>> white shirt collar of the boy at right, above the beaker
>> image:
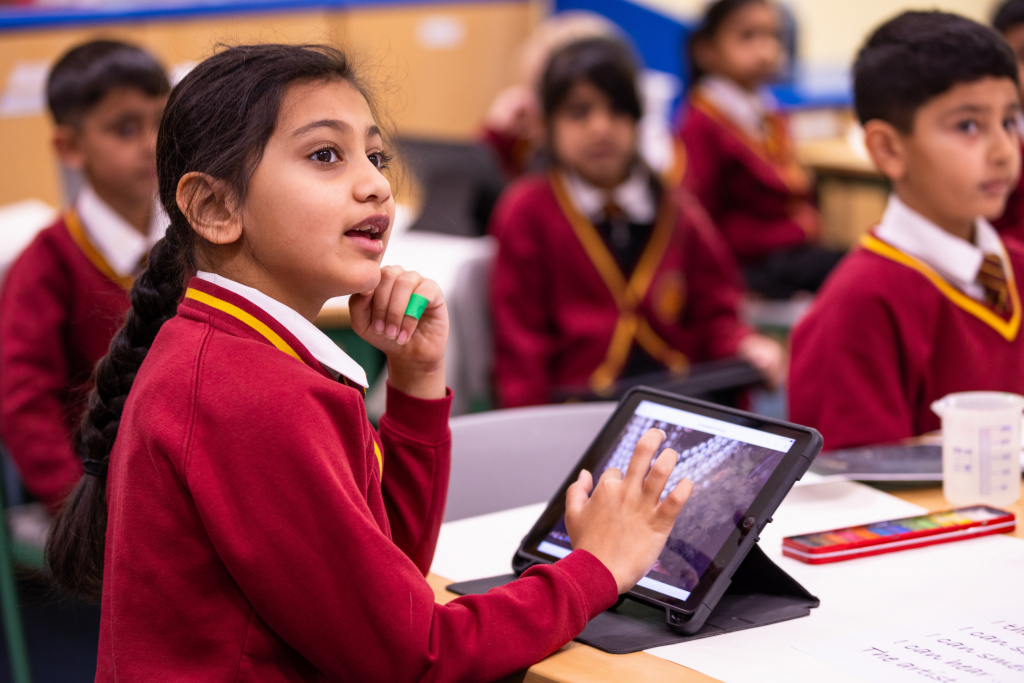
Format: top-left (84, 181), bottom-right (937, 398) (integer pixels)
top-left (874, 194), bottom-right (1009, 301)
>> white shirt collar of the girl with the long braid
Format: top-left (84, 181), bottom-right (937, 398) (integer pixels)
top-left (196, 270), bottom-right (370, 387)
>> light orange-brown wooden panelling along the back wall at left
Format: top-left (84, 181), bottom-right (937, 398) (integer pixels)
top-left (0, 0), bottom-right (546, 206)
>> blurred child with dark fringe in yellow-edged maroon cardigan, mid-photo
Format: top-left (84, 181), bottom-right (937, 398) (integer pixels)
top-left (490, 38), bottom-right (784, 407)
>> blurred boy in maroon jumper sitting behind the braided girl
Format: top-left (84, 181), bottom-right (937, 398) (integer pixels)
top-left (0, 41), bottom-right (170, 510)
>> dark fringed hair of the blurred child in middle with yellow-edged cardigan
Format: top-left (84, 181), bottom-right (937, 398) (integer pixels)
top-left (541, 37), bottom-right (643, 121)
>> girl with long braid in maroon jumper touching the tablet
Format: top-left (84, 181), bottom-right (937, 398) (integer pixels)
top-left (41, 45), bottom-right (689, 681)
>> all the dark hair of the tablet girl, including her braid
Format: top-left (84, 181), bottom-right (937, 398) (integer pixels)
top-left (46, 45), bottom-right (374, 599)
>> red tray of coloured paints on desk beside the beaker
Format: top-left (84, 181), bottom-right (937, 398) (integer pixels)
top-left (782, 505), bottom-right (1017, 564)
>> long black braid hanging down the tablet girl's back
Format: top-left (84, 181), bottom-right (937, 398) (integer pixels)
top-left (46, 225), bottom-right (191, 599)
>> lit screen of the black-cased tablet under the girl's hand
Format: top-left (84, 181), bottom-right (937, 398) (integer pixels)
top-left (538, 400), bottom-right (795, 600)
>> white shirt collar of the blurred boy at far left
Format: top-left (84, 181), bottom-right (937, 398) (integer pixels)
top-left (75, 183), bottom-right (170, 278)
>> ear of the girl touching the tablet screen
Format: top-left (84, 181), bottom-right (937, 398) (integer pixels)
top-left (176, 172), bottom-right (242, 245)
